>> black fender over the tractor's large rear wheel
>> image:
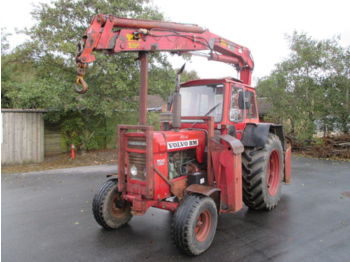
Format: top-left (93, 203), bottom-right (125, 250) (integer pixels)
top-left (242, 123), bottom-right (286, 151)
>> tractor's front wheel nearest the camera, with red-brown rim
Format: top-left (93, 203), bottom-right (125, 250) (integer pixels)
top-left (171, 195), bottom-right (218, 256)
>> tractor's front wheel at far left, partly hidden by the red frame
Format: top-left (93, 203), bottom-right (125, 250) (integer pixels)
top-left (92, 179), bottom-right (132, 230)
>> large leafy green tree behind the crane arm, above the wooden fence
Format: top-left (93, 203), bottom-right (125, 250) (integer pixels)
top-left (1, 0), bottom-right (197, 149)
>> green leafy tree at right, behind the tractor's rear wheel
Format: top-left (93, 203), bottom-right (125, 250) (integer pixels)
top-left (257, 32), bottom-right (349, 140)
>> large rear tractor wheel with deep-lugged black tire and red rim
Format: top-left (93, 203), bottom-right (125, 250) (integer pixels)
top-left (242, 133), bottom-right (284, 210)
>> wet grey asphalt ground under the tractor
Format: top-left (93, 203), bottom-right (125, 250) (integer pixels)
top-left (1, 158), bottom-right (350, 262)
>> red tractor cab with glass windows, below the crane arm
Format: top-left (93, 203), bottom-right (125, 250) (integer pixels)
top-left (180, 78), bottom-right (259, 139)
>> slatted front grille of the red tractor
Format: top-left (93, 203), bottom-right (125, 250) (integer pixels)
top-left (128, 137), bottom-right (146, 180)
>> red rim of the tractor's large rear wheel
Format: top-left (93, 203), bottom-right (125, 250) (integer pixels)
top-left (267, 150), bottom-right (280, 196)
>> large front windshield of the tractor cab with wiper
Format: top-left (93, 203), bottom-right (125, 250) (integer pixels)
top-left (180, 84), bottom-right (224, 122)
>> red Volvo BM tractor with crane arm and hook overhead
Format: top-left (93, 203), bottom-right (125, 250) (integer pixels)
top-left (76, 14), bottom-right (291, 255)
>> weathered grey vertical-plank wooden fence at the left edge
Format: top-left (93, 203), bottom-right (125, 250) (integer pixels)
top-left (1, 109), bottom-right (45, 165)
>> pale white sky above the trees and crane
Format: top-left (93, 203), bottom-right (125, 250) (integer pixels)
top-left (1, 0), bottom-right (350, 82)
